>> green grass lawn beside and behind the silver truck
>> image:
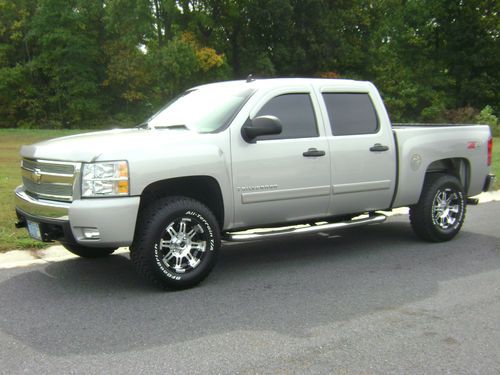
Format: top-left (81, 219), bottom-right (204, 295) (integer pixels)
top-left (0, 129), bottom-right (500, 251)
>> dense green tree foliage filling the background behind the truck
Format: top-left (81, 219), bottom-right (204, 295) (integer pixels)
top-left (0, 0), bottom-right (500, 128)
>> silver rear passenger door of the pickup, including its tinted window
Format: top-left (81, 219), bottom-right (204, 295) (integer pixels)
top-left (321, 89), bottom-right (396, 215)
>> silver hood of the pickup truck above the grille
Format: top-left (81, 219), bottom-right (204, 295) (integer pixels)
top-left (21, 128), bottom-right (203, 162)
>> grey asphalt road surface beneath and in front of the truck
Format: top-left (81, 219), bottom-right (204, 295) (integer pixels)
top-left (0, 202), bottom-right (500, 375)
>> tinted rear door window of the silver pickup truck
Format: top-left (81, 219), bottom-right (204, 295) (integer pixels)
top-left (323, 93), bottom-right (378, 135)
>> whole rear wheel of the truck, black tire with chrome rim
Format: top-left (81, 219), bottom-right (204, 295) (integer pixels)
top-left (410, 173), bottom-right (466, 242)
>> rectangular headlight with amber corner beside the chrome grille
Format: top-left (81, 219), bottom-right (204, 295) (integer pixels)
top-left (82, 161), bottom-right (129, 197)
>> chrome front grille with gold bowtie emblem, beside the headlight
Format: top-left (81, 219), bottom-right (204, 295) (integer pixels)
top-left (21, 159), bottom-right (80, 202)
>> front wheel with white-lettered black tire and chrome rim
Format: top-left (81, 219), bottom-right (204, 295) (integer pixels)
top-left (130, 197), bottom-right (220, 289)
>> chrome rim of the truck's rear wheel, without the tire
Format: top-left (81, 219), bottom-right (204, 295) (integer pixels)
top-left (432, 188), bottom-right (462, 230)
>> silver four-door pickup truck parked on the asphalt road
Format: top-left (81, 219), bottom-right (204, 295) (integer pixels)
top-left (15, 79), bottom-right (494, 288)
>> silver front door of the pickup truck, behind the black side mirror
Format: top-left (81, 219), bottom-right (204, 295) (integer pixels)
top-left (231, 85), bottom-right (330, 227)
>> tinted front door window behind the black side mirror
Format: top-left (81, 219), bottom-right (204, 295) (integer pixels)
top-left (257, 94), bottom-right (318, 140)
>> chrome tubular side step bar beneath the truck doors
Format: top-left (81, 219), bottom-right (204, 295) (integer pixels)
top-left (222, 213), bottom-right (387, 242)
